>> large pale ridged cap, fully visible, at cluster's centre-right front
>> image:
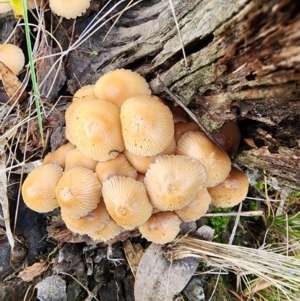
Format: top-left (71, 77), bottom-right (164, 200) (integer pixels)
top-left (144, 155), bottom-right (206, 211)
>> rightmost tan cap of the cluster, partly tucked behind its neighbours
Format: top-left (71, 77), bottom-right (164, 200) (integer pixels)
top-left (208, 166), bottom-right (249, 208)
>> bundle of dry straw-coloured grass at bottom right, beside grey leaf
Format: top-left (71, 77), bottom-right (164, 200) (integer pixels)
top-left (167, 236), bottom-right (300, 300)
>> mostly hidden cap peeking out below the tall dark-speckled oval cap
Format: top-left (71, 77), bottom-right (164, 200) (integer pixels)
top-left (123, 138), bottom-right (176, 173)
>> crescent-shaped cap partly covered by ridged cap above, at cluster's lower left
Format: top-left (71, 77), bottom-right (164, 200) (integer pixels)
top-left (61, 200), bottom-right (109, 235)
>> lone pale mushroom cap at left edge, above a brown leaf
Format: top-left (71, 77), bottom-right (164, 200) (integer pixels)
top-left (0, 44), bottom-right (25, 75)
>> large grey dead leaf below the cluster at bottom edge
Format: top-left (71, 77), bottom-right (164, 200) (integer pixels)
top-left (134, 243), bottom-right (199, 301)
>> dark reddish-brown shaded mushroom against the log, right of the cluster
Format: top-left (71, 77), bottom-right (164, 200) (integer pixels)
top-left (212, 121), bottom-right (241, 157)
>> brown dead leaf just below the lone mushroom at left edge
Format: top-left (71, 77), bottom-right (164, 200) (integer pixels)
top-left (0, 62), bottom-right (27, 105)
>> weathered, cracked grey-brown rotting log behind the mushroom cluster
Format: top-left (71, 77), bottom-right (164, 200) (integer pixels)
top-left (67, 0), bottom-right (300, 189)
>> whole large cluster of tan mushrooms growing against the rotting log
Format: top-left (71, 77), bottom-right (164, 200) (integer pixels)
top-left (22, 69), bottom-right (248, 244)
